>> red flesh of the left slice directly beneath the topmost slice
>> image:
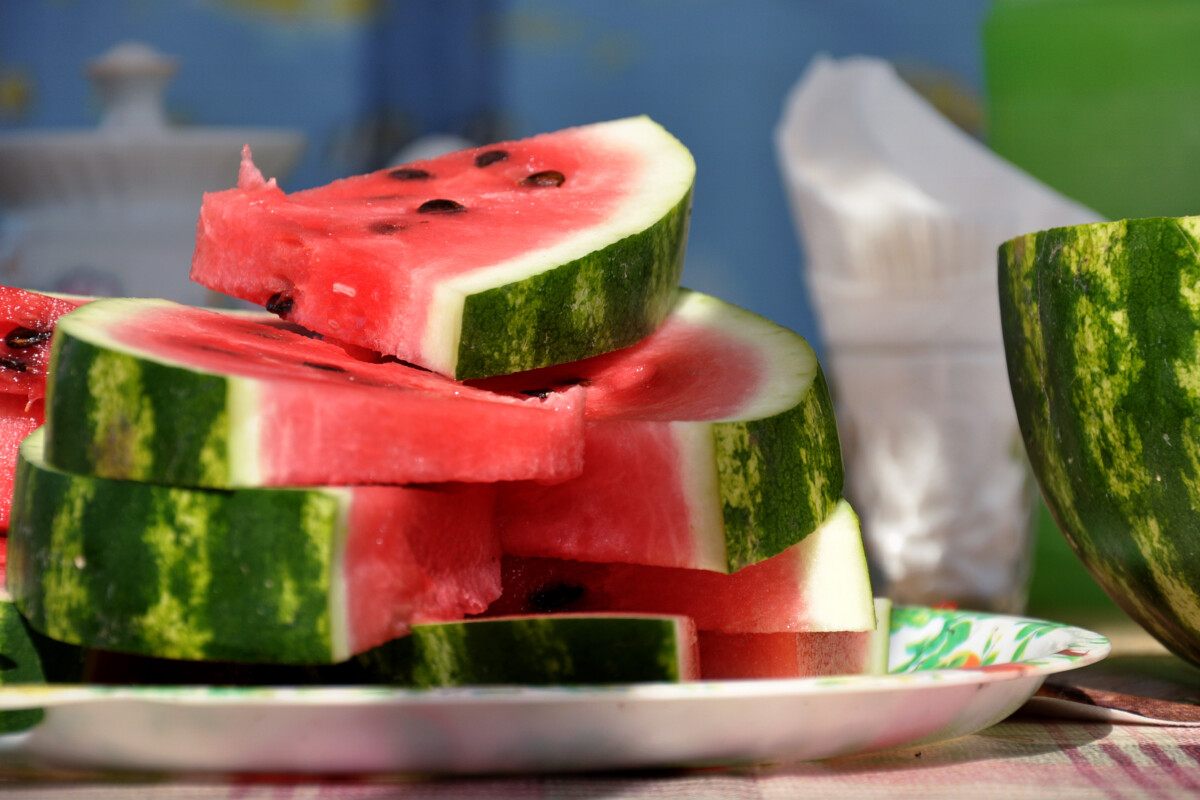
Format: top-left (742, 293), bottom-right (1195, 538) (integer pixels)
top-left (106, 301), bottom-right (583, 486)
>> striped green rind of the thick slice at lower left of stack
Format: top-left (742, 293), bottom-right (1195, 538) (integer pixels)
top-left (7, 428), bottom-right (350, 663)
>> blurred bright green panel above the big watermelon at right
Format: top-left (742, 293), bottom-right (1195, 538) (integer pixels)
top-left (983, 0), bottom-right (1200, 219)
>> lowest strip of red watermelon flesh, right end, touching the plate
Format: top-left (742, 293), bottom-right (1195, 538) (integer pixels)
top-left (700, 631), bottom-right (874, 680)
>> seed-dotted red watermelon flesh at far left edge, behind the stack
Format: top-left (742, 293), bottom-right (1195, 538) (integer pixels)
top-left (0, 285), bottom-right (88, 402)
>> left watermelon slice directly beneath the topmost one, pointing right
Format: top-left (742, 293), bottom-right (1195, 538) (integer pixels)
top-left (46, 299), bottom-right (583, 488)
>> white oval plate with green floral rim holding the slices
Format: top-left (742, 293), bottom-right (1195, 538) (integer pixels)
top-left (0, 607), bottom-right (1110, 774)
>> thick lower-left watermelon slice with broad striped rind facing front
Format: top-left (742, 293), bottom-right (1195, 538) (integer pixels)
top-left (7, 427), bottom-right (500, 663)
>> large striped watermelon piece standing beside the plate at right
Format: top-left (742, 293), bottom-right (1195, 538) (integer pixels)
top-left (1000, 217), bottom-right (1200, 663)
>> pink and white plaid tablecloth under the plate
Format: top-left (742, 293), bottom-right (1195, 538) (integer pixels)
top-left (0, 714), bottom-right (1200, 800)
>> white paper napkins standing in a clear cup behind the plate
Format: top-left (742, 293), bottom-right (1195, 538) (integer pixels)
top-left (775, 56), bottom-right (1099, 613)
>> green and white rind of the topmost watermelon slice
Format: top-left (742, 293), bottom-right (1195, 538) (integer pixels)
top-left (419, 115), bottom-right (696, 380)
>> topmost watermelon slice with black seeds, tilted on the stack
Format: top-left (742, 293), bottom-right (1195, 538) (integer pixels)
top-left (191, 116), bottom-right (695, 378)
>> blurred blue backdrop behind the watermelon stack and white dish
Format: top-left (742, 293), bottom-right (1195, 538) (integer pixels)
top-left (0, 0), bottom-right (988, 357)
